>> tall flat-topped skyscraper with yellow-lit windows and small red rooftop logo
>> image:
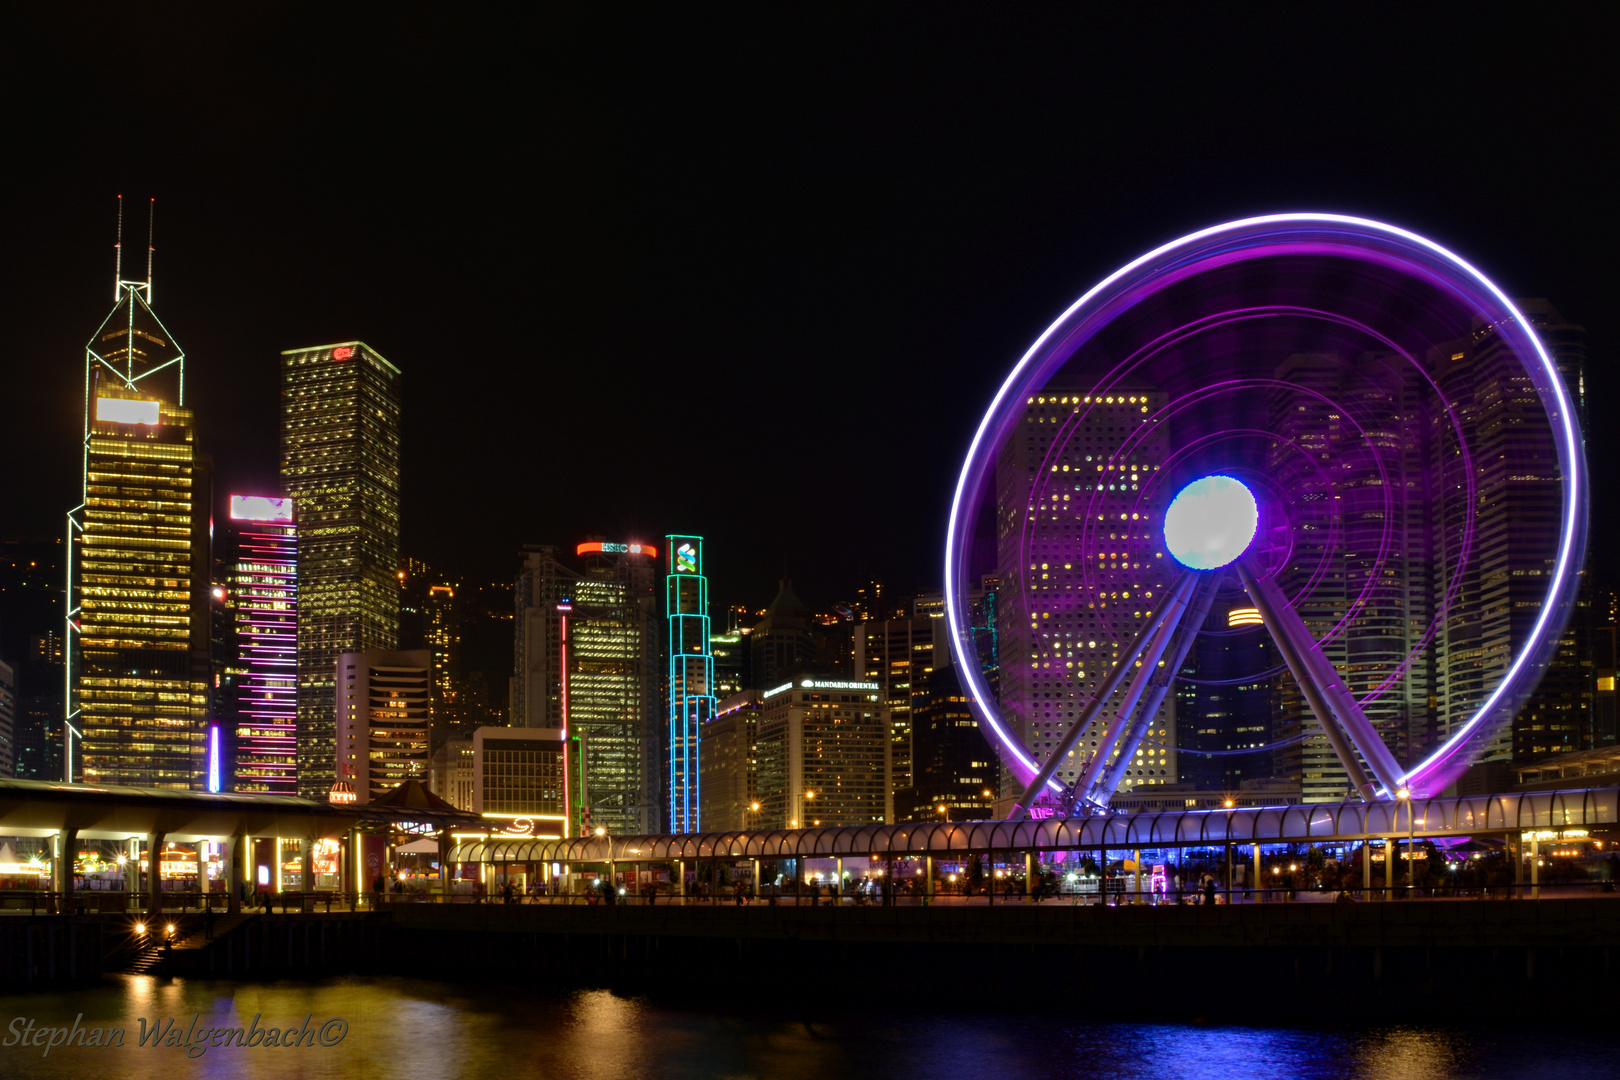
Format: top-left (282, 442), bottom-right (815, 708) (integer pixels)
top-left (282, 342), bottom-right (400, 798)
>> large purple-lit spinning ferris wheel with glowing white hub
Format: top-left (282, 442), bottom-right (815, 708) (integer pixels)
top-left (944, 214), bottom-right (1586, 819)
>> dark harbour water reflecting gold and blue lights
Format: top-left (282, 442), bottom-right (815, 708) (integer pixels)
top-left (0, 973), bottom-right (1620, 1080)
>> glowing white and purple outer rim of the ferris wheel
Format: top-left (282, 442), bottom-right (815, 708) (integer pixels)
top-left (944, 212), bottom-right (1589, 803)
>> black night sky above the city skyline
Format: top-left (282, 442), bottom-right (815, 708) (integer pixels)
top-left (0, 5), bottom-right (1620, 606)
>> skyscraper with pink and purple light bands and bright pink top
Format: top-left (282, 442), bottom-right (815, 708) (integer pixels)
top-left (214, 495), bottom-right (298, 795)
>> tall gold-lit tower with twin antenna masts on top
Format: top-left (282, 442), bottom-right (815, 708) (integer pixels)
top-left (63, 196), bottom-right (212, 789)
